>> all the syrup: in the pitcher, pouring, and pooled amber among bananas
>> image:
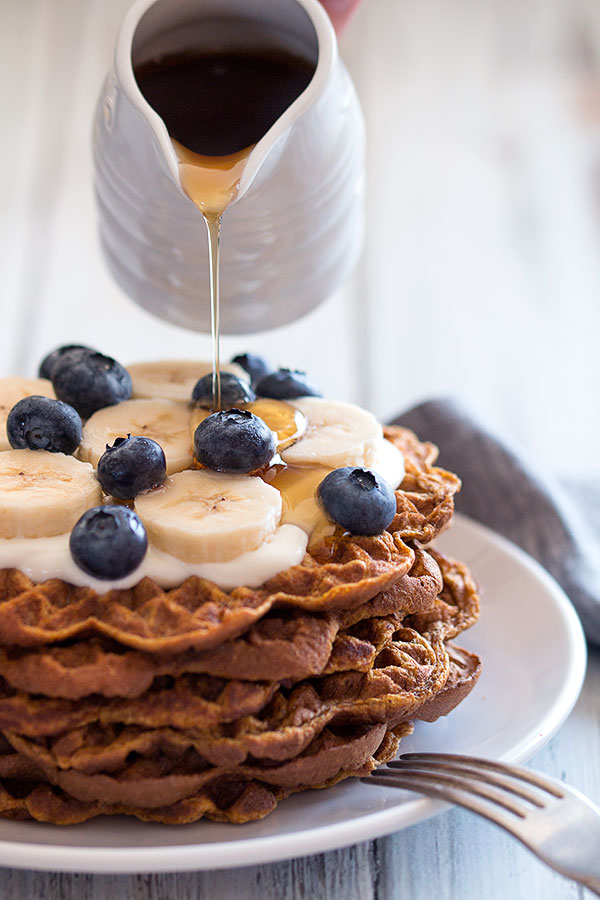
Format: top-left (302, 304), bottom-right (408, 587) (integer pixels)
top-left (135, 50), bottom-right (344, 540)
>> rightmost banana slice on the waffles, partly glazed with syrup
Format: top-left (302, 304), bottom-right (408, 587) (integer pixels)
top-left (281, 397), bottom-right (383, 469)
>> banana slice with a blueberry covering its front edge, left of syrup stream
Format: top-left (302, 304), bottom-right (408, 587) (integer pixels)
top-left (78, 400), bottom-right (193, 475)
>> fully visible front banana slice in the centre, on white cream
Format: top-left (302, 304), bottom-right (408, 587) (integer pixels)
top-left (135, 469), bottom-right (281, 562)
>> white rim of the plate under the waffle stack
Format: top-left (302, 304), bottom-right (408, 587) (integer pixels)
top-left (0, 513), bottom-right (587, 874)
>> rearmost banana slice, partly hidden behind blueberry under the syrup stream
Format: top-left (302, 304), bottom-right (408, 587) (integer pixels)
top-left (127, 359), bottom-right (250, 403)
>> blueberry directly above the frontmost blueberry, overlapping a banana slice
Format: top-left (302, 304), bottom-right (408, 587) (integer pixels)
top-left (96, 435), bottom-right (167, 500)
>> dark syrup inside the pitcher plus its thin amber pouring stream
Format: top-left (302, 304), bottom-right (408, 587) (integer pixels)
top-left (135, 48), bottom-right (315, 411)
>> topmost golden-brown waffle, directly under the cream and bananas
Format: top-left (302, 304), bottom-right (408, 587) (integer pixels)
top-left (0, 428), bottom-right (459, 654)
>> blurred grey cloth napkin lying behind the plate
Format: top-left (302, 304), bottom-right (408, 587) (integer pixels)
top-left (393, 399), bottom-right (600, 644)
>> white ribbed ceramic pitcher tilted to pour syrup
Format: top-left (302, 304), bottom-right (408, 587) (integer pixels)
top-left (94, 0), bottom-right (364, 334)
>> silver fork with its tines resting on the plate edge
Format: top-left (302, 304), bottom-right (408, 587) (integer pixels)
top-left (361, 753), bottom-right (600, 896)
